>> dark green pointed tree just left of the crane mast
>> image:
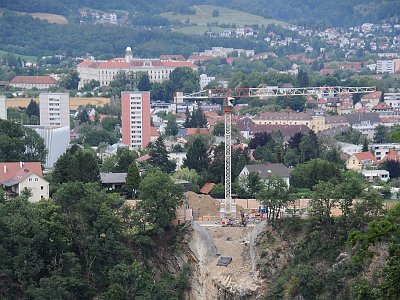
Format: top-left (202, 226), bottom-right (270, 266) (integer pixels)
top-left (183, 135), bottom-right (209, 173)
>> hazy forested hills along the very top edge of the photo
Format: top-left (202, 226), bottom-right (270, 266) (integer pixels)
top-left (2, 0), bottom-right (400, 27)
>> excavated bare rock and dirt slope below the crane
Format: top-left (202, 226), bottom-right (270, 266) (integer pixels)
top-left (151, 223), bottom-right (282, 300)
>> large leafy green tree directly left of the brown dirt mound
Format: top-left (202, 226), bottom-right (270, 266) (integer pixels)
top-left (138, 172), bottom-right (183, 229)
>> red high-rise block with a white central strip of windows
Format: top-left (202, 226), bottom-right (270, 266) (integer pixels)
top-left (121, 92), bottom-right (151, 149)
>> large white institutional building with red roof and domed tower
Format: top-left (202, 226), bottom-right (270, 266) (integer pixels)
top-left (77, 47), bottom-right (197, 88)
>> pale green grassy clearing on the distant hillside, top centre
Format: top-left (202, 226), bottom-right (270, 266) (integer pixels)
top-left (161, 5), bottom-right (283, 32)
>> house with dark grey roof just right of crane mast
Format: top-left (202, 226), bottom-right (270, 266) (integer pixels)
top-left (239, 163), bottom-right (290, 186)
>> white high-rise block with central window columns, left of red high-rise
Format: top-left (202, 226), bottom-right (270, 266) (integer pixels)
top-left (39, 93), bottom-right (70, 128)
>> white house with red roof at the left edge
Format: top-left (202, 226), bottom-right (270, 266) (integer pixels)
top-left (0, 162), bottom-right (49, 203)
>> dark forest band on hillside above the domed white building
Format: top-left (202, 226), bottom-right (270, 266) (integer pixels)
top-left (0, 12), bottom-right (266, 58)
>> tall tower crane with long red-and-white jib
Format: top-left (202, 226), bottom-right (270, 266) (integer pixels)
top-left (174, 86), bottom-right (376, 219)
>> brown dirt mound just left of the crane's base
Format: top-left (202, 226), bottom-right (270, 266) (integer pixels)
top-left (186, 192), bottom-right (220, 217)
